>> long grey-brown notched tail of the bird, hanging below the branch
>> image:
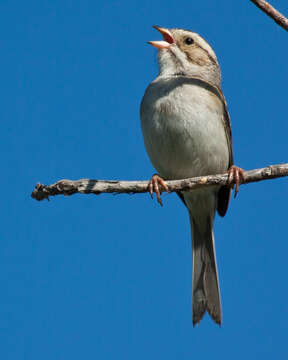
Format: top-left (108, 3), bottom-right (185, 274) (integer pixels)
top-left (189, 213), bottom-right (222, 326)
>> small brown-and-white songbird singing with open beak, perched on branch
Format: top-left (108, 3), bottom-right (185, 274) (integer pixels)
top-left (140, 26), bottom-right (244, 325)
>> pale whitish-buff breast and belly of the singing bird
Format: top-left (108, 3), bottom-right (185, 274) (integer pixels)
top-left (141, 77), bottom-right (229, 179)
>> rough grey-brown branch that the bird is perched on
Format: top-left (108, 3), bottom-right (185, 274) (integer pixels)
top-left (31, 164), bottom-right (288, 201)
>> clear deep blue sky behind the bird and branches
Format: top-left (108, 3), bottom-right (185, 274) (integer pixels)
top-left (0, 0), bottom-right (288, 360)
